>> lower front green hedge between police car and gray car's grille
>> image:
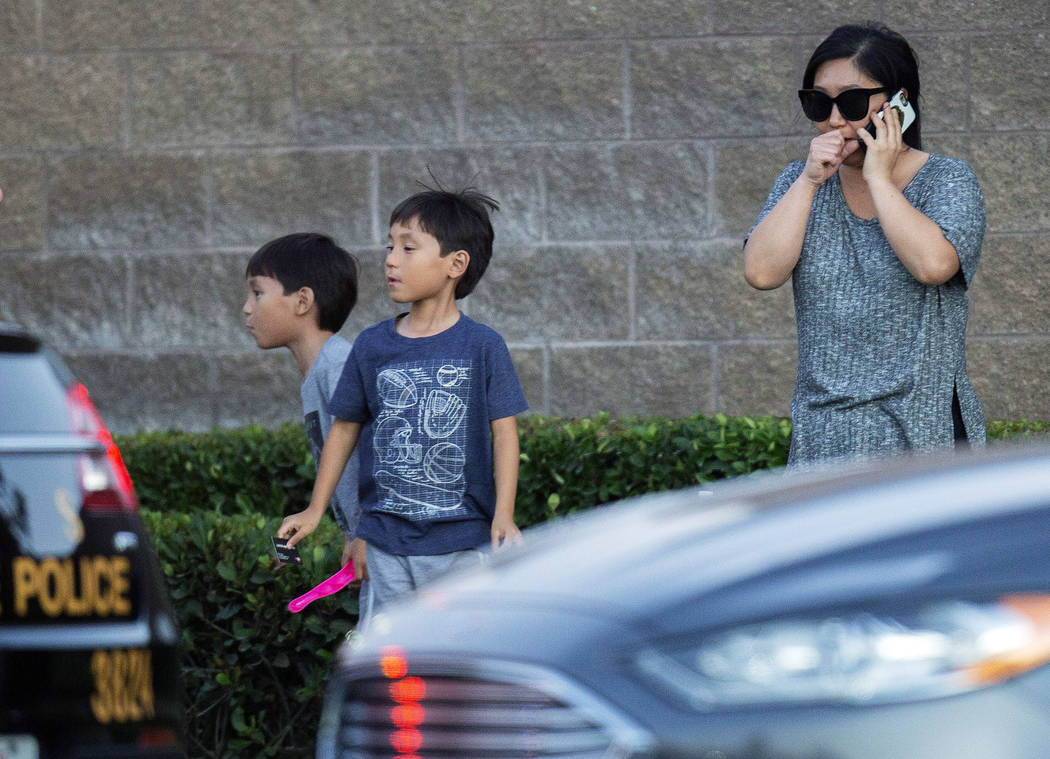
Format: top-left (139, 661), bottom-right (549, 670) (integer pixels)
top-left (142, 510), bottom-right (357, 759)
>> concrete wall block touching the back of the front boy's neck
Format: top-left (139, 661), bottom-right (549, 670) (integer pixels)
top-left (469, 247), bottom-right (631, 341)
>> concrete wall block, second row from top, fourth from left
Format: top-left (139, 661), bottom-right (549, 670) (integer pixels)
top-left (463, 43), bottom-right (624, 141)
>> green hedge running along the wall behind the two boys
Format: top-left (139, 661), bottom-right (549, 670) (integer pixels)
top-left (117, 415), bottom-right (791, 527)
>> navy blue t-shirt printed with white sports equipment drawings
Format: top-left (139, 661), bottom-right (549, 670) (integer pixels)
top-left (329, 314), bottom-right (528, 555)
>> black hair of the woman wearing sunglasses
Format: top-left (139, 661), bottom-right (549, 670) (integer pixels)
top-left (802, 21), bottom-right (922, 149)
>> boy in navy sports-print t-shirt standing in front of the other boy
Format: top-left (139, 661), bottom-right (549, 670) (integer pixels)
top-left (277, 183), bottom-right (527, 608)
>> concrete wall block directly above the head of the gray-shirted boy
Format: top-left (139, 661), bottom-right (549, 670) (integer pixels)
top-left (212, 151), bottom-right (374, 249)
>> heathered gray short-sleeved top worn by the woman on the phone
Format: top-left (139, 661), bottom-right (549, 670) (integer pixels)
top-left (756, 154), bottom-right (985, 465)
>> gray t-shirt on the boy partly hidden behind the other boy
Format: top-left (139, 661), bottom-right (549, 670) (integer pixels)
top-left (300, 335), bottom-right (361, 539)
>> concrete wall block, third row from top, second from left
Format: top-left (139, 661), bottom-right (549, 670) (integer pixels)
top-left (47, 153), bottom-right (206, 248)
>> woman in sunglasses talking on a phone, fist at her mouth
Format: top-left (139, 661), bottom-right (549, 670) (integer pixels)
top-left (744, 23), bottom-right (985, 465)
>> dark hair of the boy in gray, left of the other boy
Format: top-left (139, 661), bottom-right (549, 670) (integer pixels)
top-left (245, 232), bottom-right (357, 332)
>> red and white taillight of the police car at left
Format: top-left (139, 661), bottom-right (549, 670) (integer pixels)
top-left (66, 382), bottom-right (139, 510)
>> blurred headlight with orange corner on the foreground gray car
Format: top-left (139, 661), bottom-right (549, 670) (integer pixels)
top-left (635, 594), bottom-right (1050, 710)
